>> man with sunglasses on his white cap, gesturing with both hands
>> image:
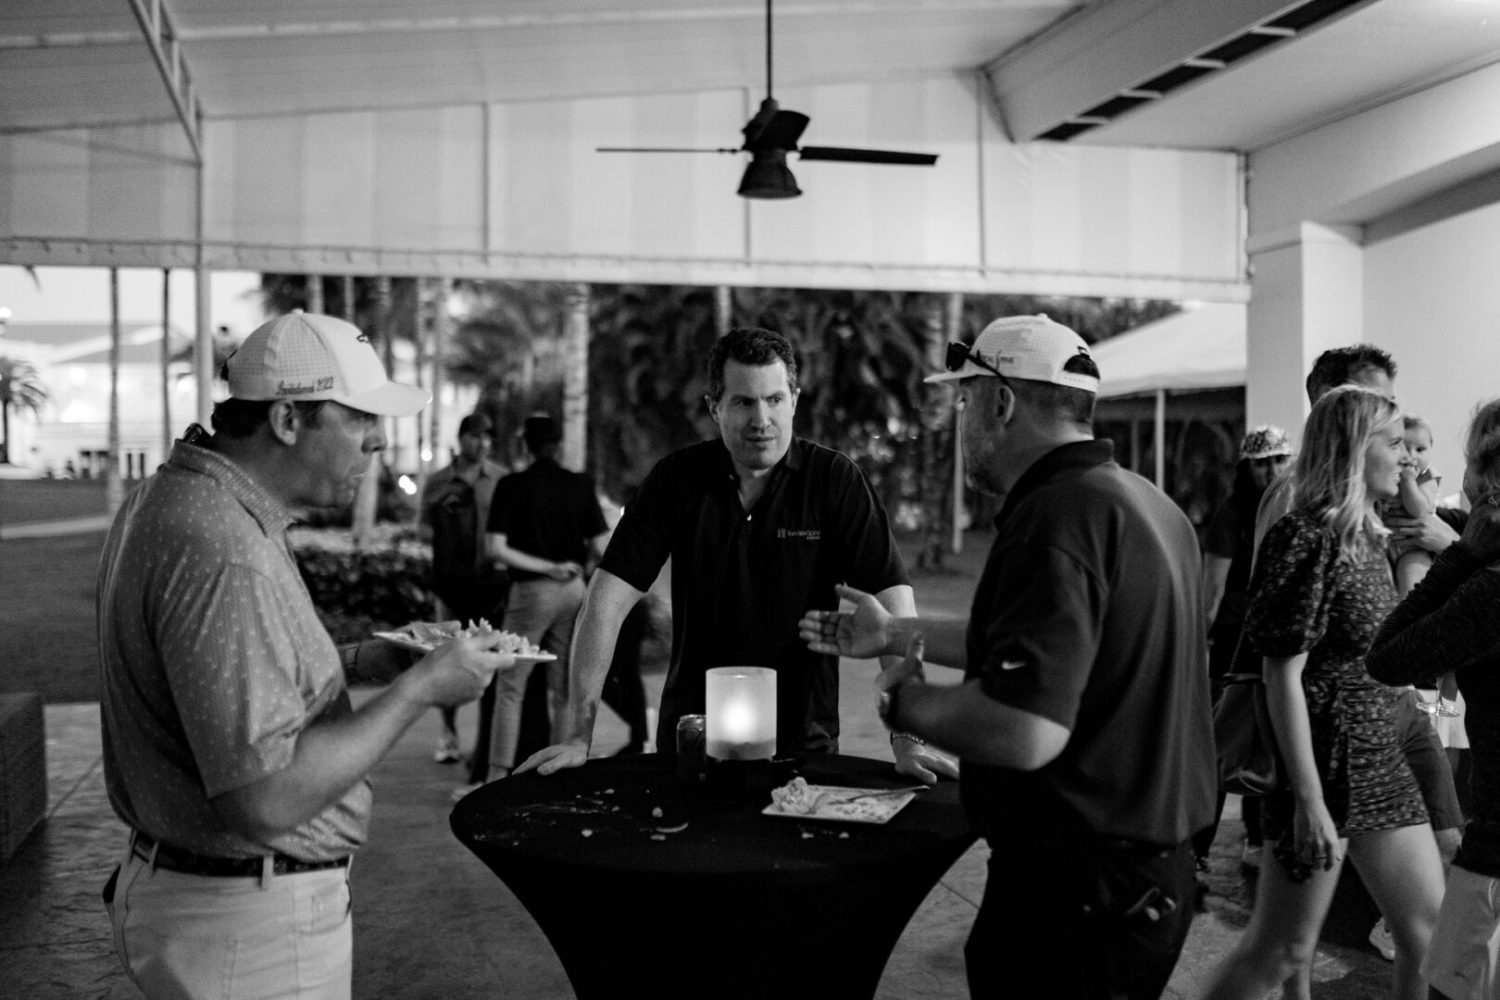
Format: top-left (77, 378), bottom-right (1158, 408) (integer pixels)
top-left (803, 316), bottom-right (1215, 999)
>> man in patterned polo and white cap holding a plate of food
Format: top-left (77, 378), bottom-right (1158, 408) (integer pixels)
top-left (98, 313), bottom-right (515, 1000)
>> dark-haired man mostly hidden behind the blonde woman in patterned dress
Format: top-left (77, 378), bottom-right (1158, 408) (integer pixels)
top-left (1256, 343), bottom-right (1464, 965)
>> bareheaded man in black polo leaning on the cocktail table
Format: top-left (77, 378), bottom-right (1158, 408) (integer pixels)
top-left (521, 330), bottom-right (951, 781)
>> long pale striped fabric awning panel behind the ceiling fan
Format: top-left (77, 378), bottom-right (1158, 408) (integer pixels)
top-left (184, 75), bottom-right (1244, 298)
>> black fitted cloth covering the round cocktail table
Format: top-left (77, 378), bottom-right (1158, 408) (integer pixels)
top-left (450, 754), bottom-right (975, 1000)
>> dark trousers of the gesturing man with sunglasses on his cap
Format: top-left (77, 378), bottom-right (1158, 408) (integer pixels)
top-left (963, 841), bottom-right (1194, 1000)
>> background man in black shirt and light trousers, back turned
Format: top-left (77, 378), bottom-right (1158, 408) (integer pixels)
top-left (488, 414), bottom-right (609, 780)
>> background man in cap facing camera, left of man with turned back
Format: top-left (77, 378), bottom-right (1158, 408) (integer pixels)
top-left (417, 414), bottom-right (507, 781)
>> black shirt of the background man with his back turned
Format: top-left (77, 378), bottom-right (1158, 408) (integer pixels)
top-left (486, 459), bottom-right (609, 583)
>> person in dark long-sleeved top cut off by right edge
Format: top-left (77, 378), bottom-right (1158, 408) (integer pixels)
top-left (1368, 399), bottom-right (1500, 1000)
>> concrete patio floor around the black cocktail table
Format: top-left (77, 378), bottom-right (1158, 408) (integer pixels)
top-left (0, 661), bottom-right (1389, 1000)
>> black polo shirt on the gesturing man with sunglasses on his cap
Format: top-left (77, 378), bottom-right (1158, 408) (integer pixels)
top-left (960, 441), bottom-right (1215, 846)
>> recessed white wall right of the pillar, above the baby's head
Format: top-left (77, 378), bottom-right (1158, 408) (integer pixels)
top-left (1365, 204), bottom-right (1500, 493)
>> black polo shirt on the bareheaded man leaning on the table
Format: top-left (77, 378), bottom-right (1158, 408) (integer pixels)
top-left (603, 439), bottom-right (908, 753)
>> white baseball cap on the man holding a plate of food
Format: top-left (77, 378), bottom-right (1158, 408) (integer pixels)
top-left (225, 310), bottom-right (432, 417)
